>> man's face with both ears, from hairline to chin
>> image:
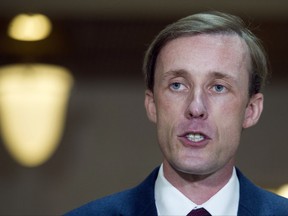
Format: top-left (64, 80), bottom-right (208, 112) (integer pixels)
top-left (145, 34), bottom-right (263, 175)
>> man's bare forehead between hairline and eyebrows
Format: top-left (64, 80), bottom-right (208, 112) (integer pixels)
top-left (155, 34), bottom-right (251, 80)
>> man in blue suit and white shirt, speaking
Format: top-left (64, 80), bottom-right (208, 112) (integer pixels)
top-left (68, 12), bottom-right (288, 216)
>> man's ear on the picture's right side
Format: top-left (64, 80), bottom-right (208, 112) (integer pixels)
top-left (243, 93), bottom-right (264, 128)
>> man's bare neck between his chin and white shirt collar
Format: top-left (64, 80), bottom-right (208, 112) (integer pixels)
top-left (163, 161), bottom-right (234, 205)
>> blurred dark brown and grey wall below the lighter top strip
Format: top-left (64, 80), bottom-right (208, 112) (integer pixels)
top-left (0, 3), bottom-right (288, 215)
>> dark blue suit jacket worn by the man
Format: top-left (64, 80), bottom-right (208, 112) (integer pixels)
top-left (66, 168), bottom-right (288, 216)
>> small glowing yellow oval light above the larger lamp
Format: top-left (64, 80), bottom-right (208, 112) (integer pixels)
top-left (8, 14), bottom-right (52, 41)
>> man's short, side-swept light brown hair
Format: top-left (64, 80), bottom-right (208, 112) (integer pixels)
top-left (143, 12), bottom-right (268, 96)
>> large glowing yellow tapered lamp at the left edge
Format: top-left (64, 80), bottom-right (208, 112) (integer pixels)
top-left (0, 64), bottom-right (73, 167)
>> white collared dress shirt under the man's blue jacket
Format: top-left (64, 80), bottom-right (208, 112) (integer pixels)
top-left (155, 165), bottom-right (240, 216)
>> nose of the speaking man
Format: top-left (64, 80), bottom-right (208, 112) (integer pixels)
top-left (185, 90), bottom-right (208, 120)
